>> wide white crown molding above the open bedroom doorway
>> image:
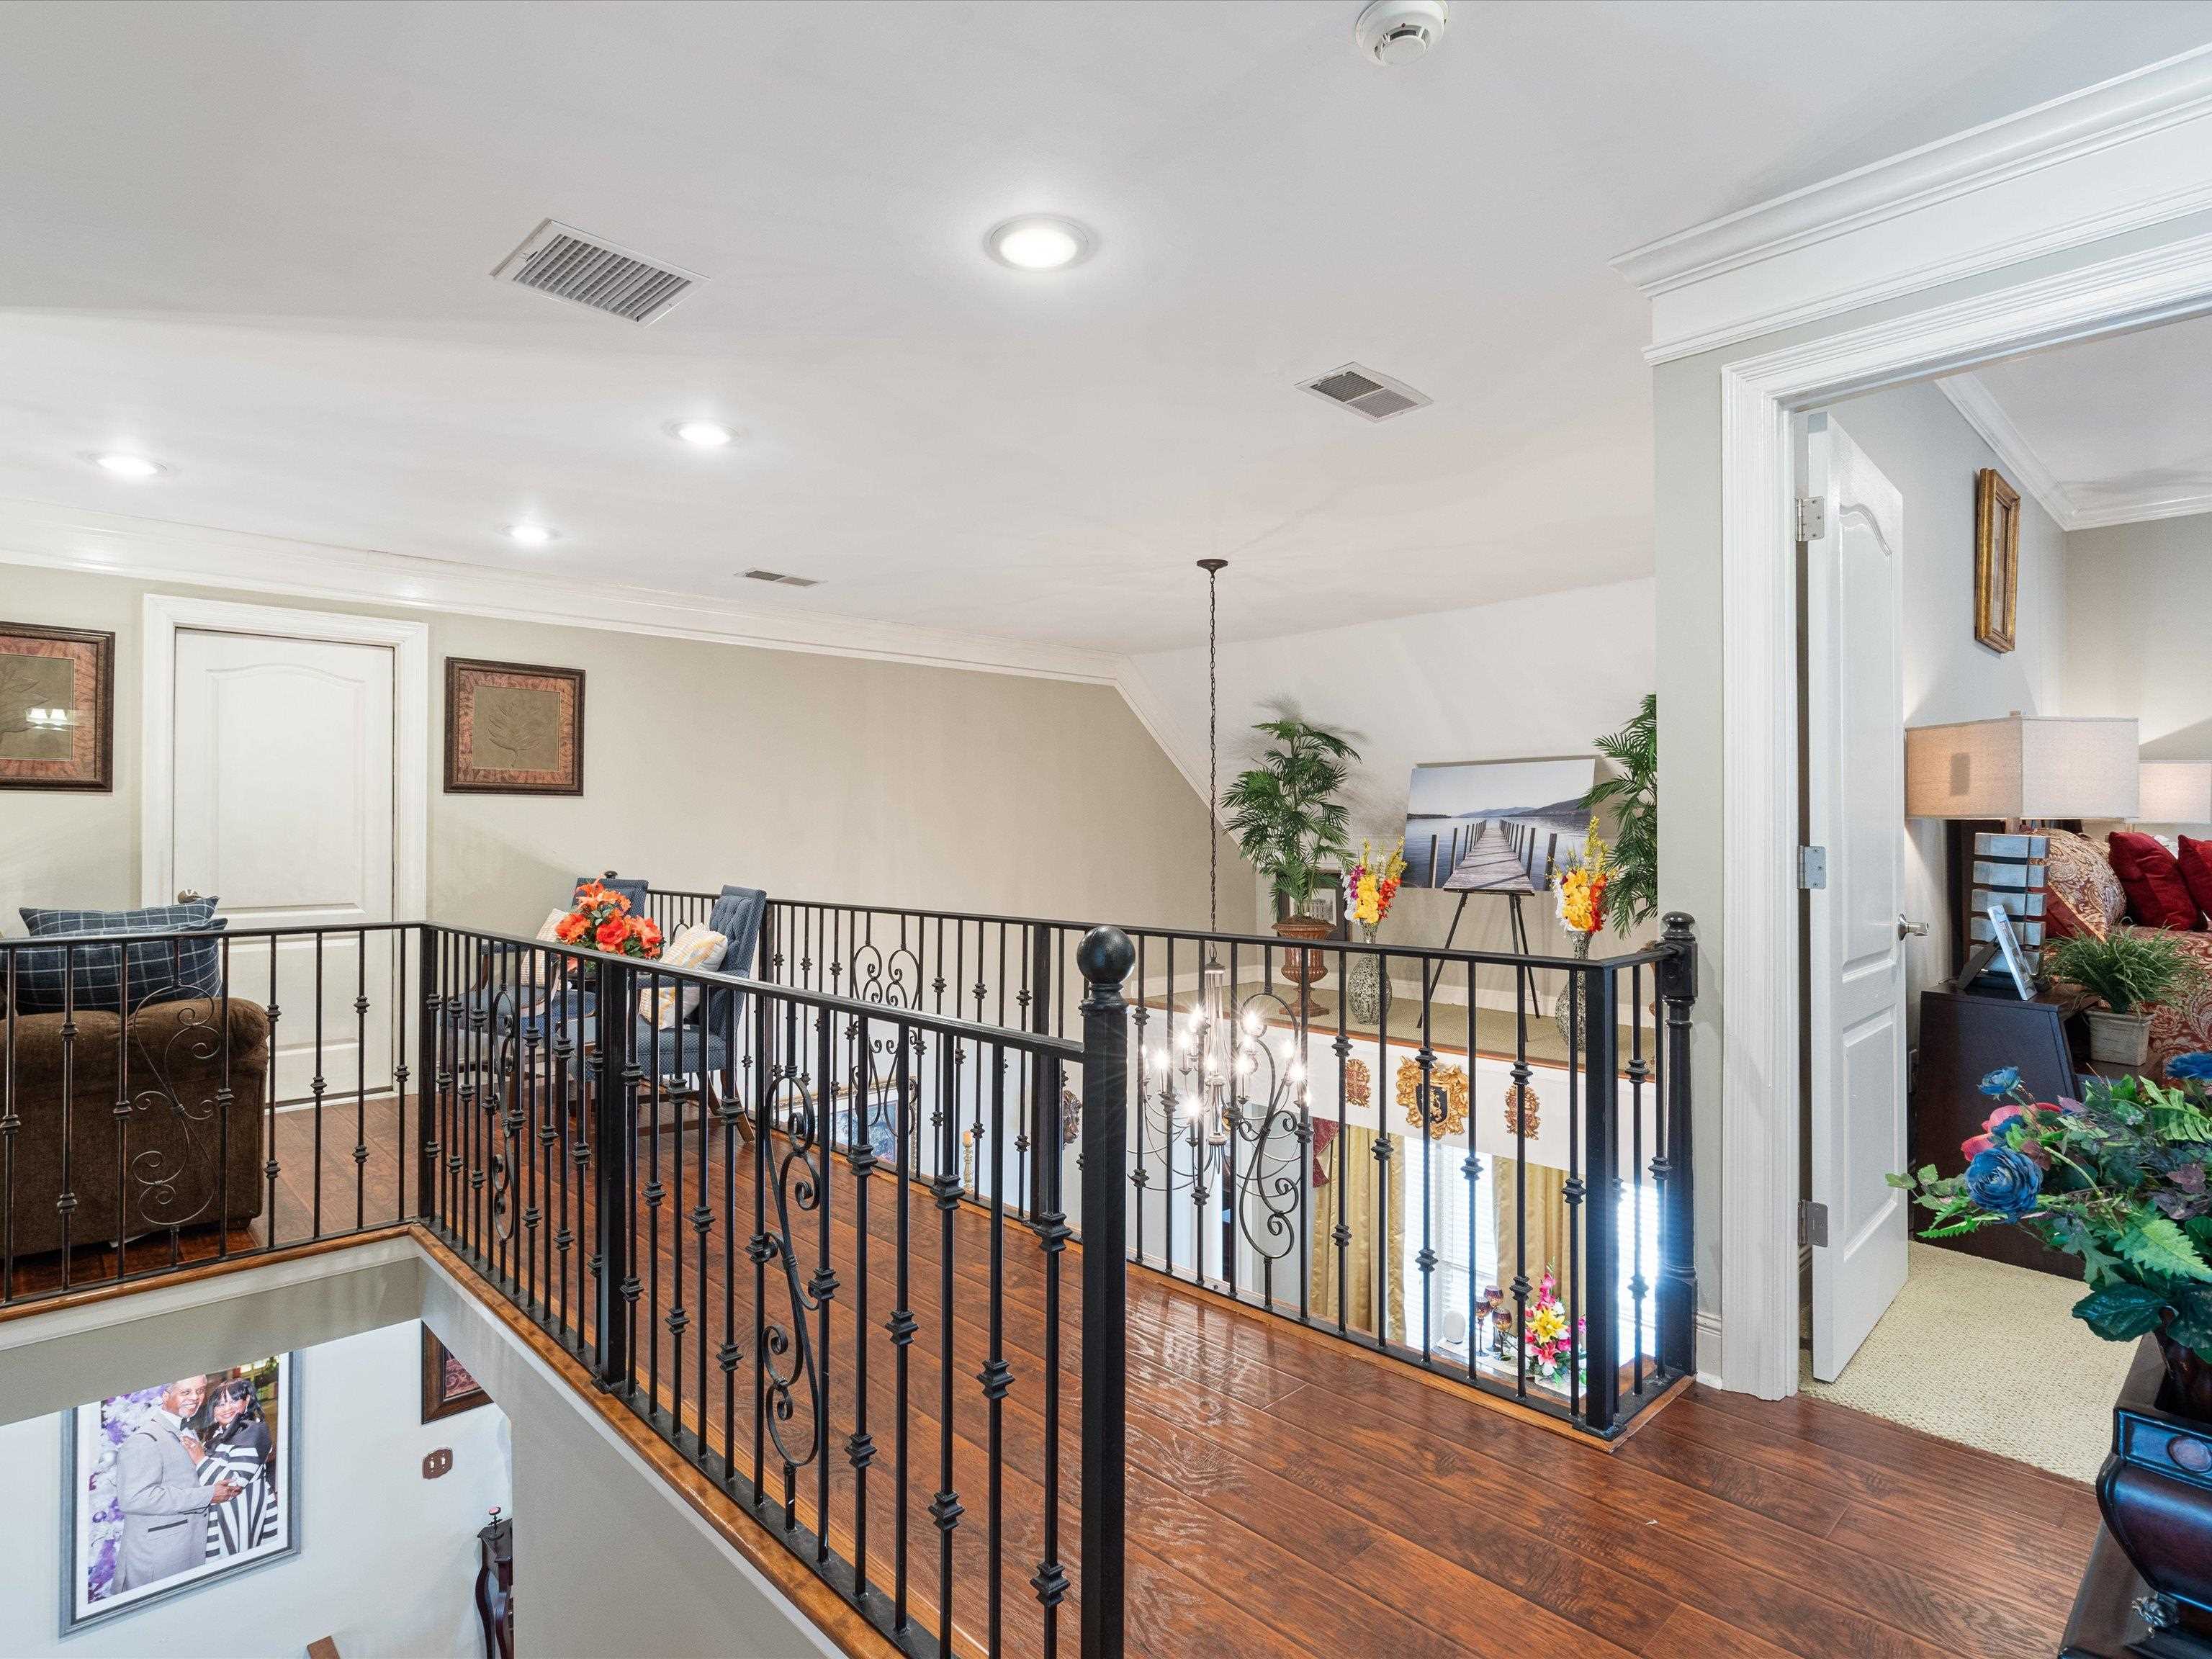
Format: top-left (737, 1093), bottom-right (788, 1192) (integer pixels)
top-left (1612, 47), bottom-right (2212, 363)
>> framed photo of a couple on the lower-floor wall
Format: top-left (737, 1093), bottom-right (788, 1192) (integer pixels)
top-left (62, 1354), bottom-right (301, 1635)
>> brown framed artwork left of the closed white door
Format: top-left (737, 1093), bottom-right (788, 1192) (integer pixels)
top-left (0, 621), bottom-right (115, 790)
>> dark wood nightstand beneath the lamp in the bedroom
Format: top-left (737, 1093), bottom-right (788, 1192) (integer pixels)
top-left (1907, 991), bottom-right (2082, 1279)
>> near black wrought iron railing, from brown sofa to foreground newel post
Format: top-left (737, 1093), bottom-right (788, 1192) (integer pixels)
top-left (0, 925), bottom-right (1133, 1659)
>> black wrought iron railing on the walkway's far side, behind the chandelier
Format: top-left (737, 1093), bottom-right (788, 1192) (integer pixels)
top-left (650, 889), bottom-right (1696, 1436)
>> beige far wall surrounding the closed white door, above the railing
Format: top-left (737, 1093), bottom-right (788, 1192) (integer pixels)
top-left (0, 564), bottom-right (1252, 931)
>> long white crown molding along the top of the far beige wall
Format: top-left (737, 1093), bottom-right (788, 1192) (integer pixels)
top-left (0, 500), bottom-right (1122, 685)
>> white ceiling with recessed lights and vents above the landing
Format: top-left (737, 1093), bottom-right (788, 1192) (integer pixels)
top-left (13, 0), bottom-right (2212, 650)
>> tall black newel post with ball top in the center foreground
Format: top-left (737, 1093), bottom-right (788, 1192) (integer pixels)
top-left (1075, 927), bottom-right (1137, 1659)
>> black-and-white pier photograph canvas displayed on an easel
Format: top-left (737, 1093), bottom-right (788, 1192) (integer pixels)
top-left (1405, 755), bottom-right (1597, 894)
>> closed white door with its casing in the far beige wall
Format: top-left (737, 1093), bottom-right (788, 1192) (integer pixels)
top-left (142, 595), bottom-right (429, 1102)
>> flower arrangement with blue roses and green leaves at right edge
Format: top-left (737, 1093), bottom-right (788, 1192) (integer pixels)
top-left (1889, 1053), bottom-right (2212, 1403)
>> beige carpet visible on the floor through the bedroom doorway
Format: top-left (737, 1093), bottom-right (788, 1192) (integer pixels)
top-left (1801, 1243), bottom-right (2134, 1480)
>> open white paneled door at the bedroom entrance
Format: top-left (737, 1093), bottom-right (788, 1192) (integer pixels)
top-left (1805, 416), bottom-right (1917, 1380)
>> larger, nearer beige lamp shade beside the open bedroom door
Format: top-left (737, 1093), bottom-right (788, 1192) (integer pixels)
top-left (1905, 714), bottom-right (2141, 819)
